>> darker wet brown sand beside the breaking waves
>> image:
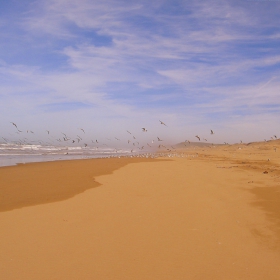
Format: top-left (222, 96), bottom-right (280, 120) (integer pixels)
top-left (0, 157), bottom-right (162, 212)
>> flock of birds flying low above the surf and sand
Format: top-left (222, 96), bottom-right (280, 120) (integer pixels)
top-left (2, 120), bottom-right (278, 153)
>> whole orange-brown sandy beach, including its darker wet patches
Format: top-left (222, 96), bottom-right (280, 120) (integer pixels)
top-left (0, 141), bottom-right (280, 280)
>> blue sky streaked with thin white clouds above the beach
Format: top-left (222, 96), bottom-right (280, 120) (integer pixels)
top-left (0, 0), bottom-right (280, 148)
